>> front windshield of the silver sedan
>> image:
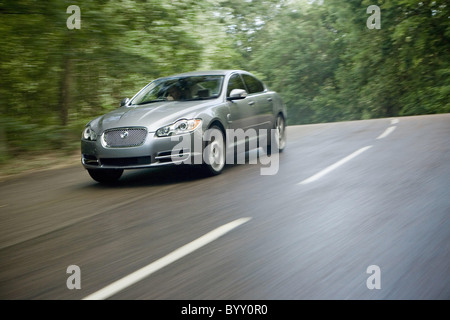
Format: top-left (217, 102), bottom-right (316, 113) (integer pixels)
top-left (131, 75), bottom-right (224, 105)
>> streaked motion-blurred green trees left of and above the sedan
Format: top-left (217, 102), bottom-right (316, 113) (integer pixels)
top-left (0, 0), bottom-right (240, 162)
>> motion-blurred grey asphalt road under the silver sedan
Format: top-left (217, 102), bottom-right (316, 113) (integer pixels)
top-left (0, 114), bottom-right (450, 300)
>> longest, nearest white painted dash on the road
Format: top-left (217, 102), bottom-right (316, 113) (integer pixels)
top-left (83, 217), bottom-right (251, 300)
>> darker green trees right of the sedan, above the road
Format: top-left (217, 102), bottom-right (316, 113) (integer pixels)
top-left (252, 0), bottom-right (450, 124)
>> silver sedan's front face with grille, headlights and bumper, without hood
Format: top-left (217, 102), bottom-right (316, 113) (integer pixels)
top-left (81, 119), bottom-right (207, 169)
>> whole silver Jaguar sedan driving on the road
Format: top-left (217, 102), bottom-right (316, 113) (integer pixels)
top-left (81, 70), bottom-right (286, 183)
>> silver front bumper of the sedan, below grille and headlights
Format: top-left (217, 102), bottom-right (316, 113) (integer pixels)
top-left (81, 131), bottom-right (203, 169)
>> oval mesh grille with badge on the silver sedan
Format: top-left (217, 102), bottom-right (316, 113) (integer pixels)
top-left (103, 128), bottom-right (147, 148)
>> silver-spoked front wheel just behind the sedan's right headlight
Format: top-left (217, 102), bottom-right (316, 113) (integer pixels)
top-left (203, 126), bottom-right (226, 176)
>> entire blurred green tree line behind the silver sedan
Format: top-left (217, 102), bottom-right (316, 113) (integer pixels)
top-left (0, 0), bottom-right (450, 163)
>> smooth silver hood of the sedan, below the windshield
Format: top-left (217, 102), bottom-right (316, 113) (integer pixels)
top-left (90, 99), bottom-right (218, 133)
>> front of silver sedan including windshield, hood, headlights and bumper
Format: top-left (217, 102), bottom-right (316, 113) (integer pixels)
top-left (81, 73), bottom-right (229, 178)
